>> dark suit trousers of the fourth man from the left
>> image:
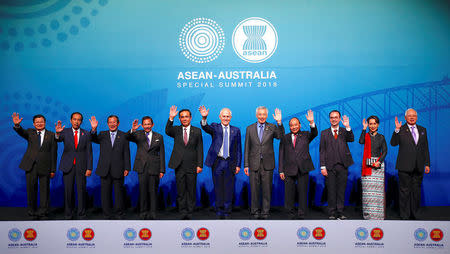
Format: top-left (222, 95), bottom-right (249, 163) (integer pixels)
top-left (139, 171), bottom-right (159, 218)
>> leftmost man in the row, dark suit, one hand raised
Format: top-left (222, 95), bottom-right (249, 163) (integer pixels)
top-left (12, 113), bottom-right (57, 219)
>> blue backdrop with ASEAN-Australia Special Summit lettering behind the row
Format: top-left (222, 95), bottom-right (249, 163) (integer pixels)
top-left (0, 0), bottom-right (450, 206)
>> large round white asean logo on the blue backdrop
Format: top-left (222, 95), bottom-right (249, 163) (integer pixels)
top-left (232, 17), bottom-right (278, 63)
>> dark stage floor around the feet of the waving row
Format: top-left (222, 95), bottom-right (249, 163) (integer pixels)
top-left (0, 206), bottom-right (450, 221)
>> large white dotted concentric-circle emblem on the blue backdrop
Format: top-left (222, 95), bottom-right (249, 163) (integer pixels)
top-left (179, 18), bottom-right (225, 63)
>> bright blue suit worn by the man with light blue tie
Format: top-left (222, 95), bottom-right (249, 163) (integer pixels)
top-left (200, 122), bottom-right (242, 216)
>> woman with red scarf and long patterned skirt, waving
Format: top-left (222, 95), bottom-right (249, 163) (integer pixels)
top-left (359, 116), bottom-right (387, 220)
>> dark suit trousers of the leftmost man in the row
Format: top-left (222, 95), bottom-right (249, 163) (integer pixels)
top-left (25, 164), bottom-right (50, 216)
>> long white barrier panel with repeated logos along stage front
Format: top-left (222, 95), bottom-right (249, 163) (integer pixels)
top-left (0, 220), bottom-right (450, 254)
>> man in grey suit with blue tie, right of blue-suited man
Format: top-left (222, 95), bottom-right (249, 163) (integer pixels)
top-left (244, 106), bottom-right (284, 219)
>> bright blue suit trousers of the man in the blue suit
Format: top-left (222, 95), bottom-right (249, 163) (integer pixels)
top-left (212, 157), bottom-right (235, 216)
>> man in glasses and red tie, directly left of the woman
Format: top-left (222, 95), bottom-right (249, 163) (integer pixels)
top-left (319, 110), bottom-right (355, 220)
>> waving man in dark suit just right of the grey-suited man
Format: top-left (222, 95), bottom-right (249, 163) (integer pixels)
top-left (278, 110), bottom-right (318, 219)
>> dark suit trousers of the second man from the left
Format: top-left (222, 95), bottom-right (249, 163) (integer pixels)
top-left (63, 165), bottom-right (87, 218)
